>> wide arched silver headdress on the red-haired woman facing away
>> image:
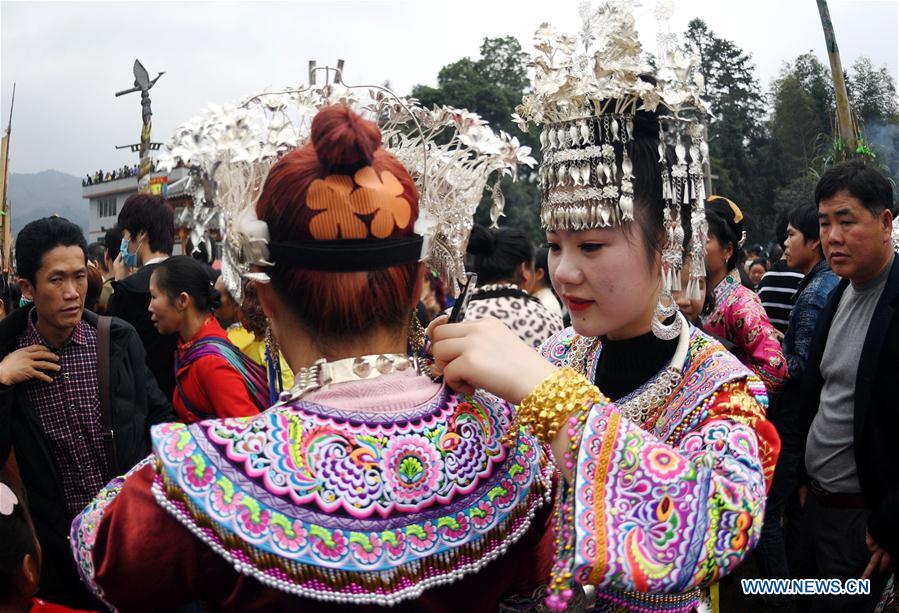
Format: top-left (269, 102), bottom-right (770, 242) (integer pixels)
top-left (160, 62), bottom-right (536, 301)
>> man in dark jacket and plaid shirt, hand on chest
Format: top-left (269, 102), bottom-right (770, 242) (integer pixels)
top-left (0, 217), bottom-right (174, 607)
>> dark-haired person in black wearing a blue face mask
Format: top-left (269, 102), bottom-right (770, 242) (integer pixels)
top-left (106, 194), bottom-right (178, 398)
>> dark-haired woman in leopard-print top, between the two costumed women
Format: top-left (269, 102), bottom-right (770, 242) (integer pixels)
top-left (465, 225), bottom-right (562, 348)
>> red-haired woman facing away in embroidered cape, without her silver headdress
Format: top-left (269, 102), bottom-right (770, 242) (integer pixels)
top-left (73, 106), bottom-right (552, 612)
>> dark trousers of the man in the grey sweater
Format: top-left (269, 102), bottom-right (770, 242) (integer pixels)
top-left (796, 492), bottom-right (892, 613)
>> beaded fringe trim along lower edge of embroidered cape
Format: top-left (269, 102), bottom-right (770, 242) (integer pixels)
top-left (152, 460), bottom-right (553, 606)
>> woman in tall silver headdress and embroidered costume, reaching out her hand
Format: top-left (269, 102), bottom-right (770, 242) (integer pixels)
top-left (430, 3), bottom-right (778, 612)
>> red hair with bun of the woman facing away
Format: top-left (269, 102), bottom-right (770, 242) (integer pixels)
top-left (256, 105), bottom-right (418, 340)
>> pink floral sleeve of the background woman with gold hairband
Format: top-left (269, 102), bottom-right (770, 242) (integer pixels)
top-left (727, 290), bottom-right (788, 391)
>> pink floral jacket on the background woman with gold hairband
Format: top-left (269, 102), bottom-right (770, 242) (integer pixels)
top-left (702, 270), bottom-right (788, 392)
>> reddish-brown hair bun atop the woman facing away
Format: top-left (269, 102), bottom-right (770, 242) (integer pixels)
top-left (311, 104), bottom-right (381, 168)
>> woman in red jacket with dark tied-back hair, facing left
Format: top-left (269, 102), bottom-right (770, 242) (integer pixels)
top-left (150, 256), bottom-right (268, 424)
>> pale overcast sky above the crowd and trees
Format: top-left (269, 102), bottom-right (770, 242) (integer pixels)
top-left (0, 0), bottom-right (899, 176)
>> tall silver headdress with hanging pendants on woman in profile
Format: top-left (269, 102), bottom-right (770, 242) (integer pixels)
top-left (514, 0), bottom-right (708, 297)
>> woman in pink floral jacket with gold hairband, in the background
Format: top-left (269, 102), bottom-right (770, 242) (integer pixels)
top-left (702, 196), bottom-right (788, 392)
